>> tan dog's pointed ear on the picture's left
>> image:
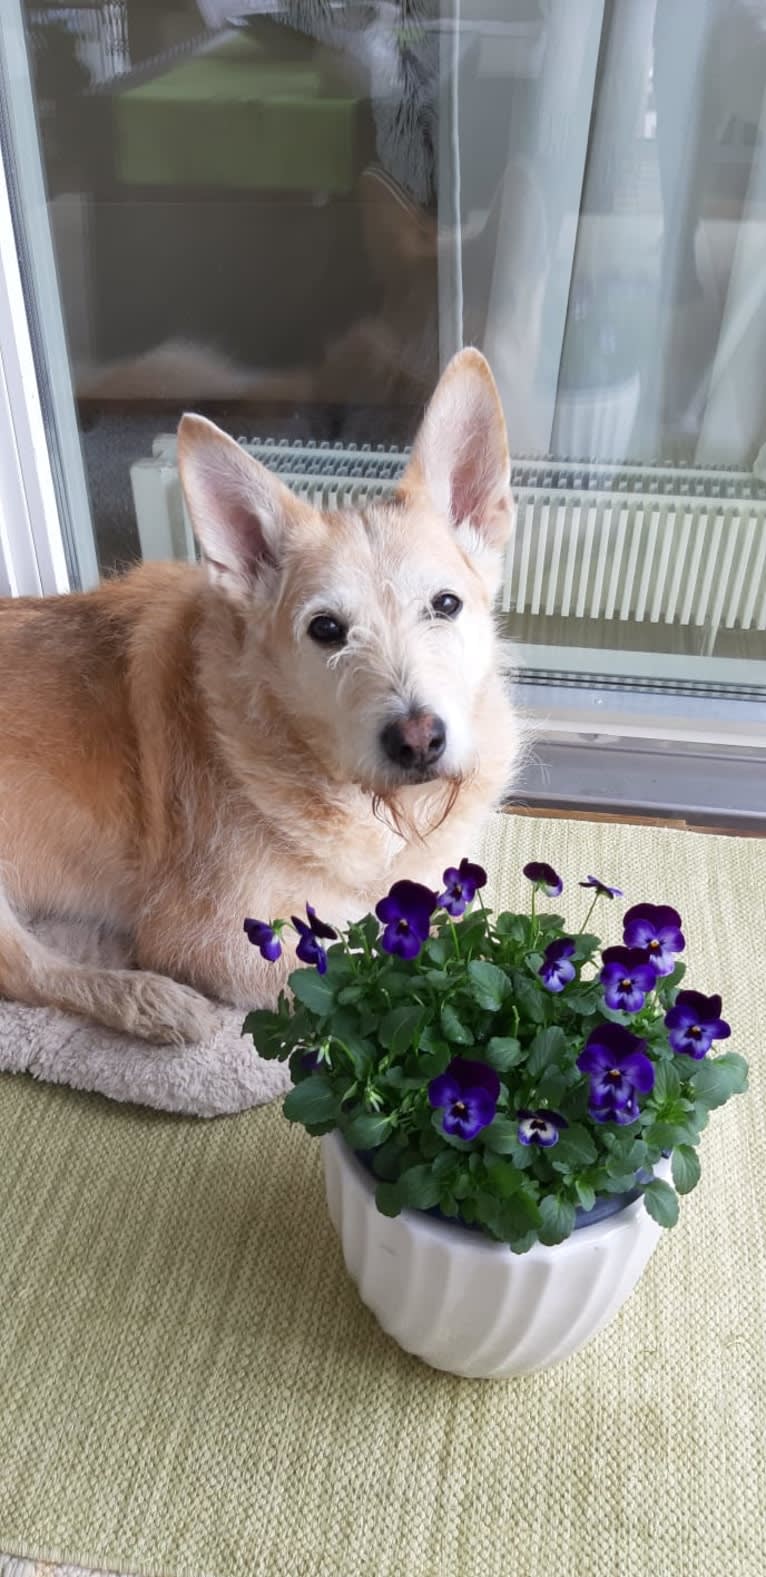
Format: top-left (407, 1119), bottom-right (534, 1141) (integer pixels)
top-left (178, 416), bottom-right (306, 598)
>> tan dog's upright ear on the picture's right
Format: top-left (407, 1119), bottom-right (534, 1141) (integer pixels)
top-left (402, 350), bottom-right (514, 580)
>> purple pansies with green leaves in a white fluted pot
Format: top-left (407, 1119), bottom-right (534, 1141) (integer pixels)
top-left (243, 859), bottom-right (747, 1378)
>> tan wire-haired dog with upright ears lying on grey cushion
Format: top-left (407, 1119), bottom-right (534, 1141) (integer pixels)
top-left (0, 350), bottom-right (519, 1042)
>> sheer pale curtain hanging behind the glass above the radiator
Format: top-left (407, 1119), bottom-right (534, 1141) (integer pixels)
top-left (457, 0), bottom-right (766, 468)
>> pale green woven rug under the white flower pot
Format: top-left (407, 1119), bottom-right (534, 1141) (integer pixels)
top-left (0, 817), bottom-right (766, 1577)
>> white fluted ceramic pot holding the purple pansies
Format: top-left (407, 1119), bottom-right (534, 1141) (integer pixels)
top-left (322, 1134), bottom-right (670, 1380)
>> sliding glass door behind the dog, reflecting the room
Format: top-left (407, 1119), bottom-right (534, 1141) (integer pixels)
top-left (0, 0), bottom-right (766, 788)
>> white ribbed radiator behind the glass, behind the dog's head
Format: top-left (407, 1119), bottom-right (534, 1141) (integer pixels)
top-left (131, 435), bottom-right (766, 651)
